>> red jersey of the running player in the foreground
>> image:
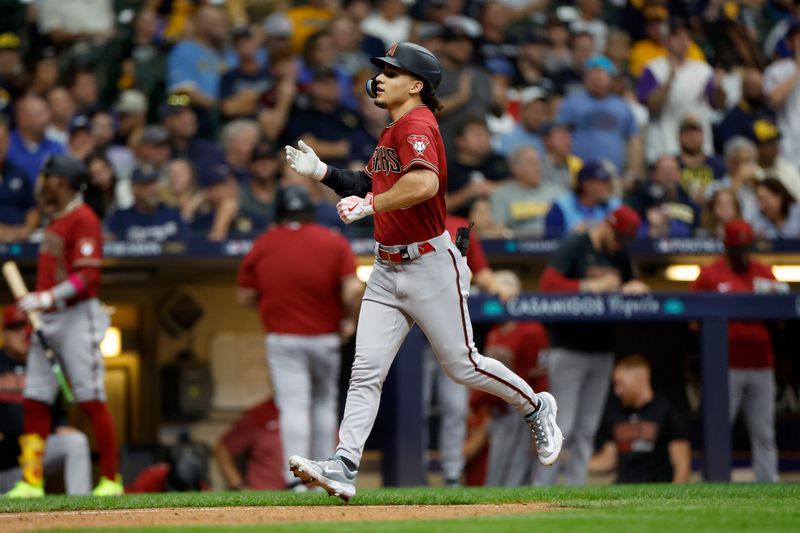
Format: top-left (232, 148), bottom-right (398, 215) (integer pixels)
top-left (365, 105), bottom-right (447, 245)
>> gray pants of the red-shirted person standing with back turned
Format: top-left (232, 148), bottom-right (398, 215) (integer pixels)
top-left (266, 333), bottom-right (342, 484)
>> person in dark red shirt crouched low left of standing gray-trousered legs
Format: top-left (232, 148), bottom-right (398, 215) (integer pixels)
top-left (214, 398), bottom-right (286, 490)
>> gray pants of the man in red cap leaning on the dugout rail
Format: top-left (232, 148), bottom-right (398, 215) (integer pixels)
top-left (534, 348), bottom-right (614, 485)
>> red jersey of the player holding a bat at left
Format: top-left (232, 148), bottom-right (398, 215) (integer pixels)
top-left (36, 204), bottom-right (103, 301)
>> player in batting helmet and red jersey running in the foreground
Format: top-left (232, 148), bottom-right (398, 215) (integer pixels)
top-left (286, 42), bottom-right (563, 501)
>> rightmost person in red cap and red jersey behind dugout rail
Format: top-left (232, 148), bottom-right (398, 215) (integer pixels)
top-left (690, 220), bottom-right (778, 482)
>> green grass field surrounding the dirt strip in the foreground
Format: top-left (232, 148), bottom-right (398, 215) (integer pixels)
top-left (0, 484), bottom-right (800, 533)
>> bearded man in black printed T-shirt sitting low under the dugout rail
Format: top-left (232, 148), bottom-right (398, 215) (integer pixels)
top-left (589, 354), bottom-right (691, 483)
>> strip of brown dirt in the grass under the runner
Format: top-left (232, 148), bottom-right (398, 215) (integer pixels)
top-left (0, 503), bottom-right (549, 533)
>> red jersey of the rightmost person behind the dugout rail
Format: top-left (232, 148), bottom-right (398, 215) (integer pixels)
top-left (690, 258), bottom-right (775, 368)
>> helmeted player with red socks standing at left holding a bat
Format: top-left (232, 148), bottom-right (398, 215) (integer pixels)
top-left (6, 155), bottom-right (123, 498)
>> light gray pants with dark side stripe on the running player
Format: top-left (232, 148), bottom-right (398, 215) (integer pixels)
top-left (336, 232), bottom-right (538, 465)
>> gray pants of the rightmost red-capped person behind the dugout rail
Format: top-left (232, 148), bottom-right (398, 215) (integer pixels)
top-left (728, 368), bottom-right (778, 482)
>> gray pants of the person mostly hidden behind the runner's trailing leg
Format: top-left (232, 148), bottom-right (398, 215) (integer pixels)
top-left (422, 346), bottom-right (466, 481)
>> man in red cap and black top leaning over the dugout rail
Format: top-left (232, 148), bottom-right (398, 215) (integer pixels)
top-left (534, 205), bottom-right (649, 485)
